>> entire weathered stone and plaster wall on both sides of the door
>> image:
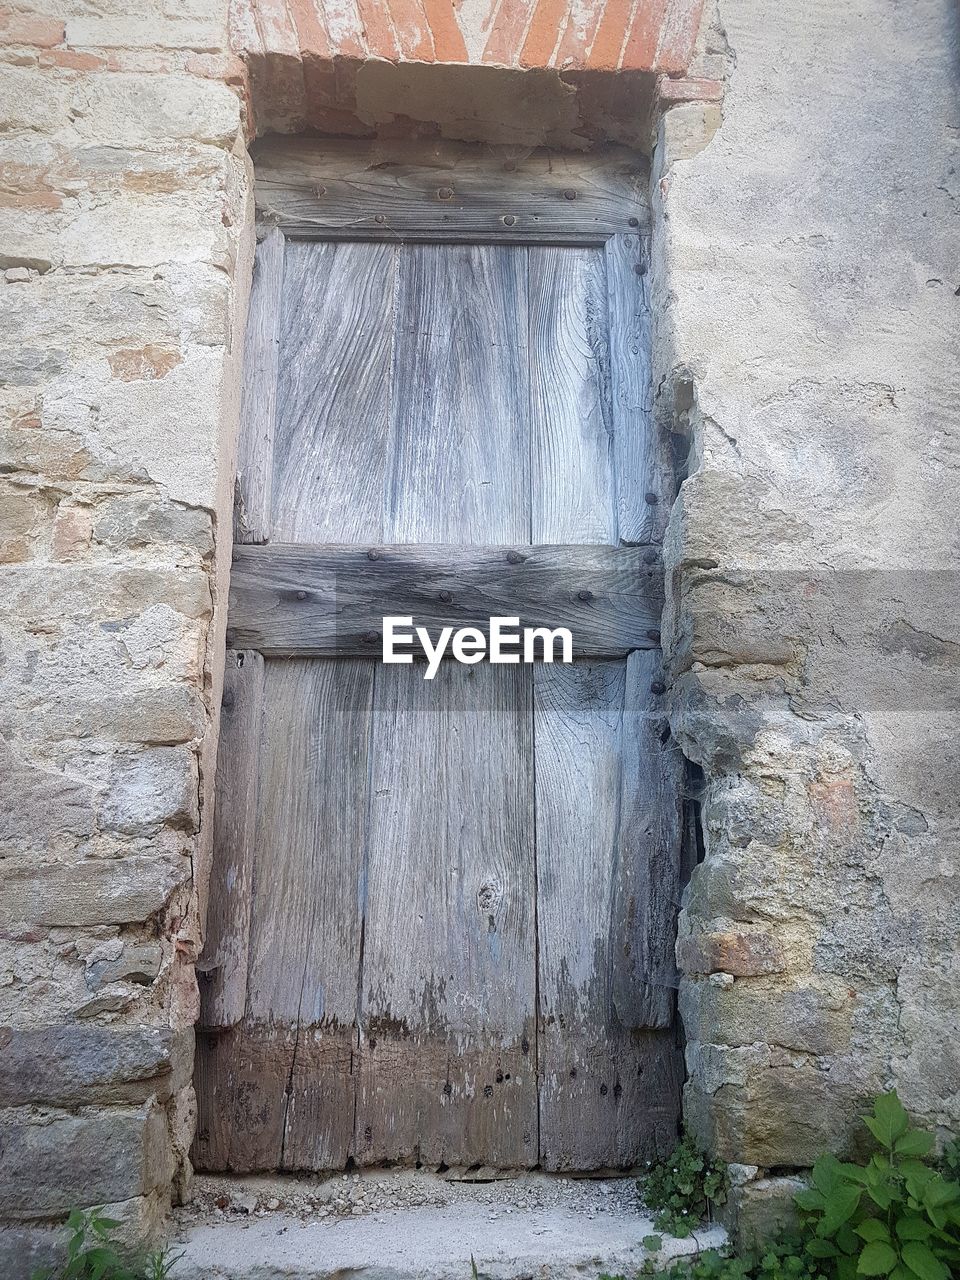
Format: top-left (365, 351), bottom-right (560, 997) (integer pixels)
top-left (0, 0), bottom-right (960, 1276)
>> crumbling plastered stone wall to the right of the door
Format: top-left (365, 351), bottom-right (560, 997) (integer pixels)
top-left (653, 0), bottom-right (960, 1233)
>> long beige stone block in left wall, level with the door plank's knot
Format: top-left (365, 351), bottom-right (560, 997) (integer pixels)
top-left (0, 856), bottom-right (191, 927)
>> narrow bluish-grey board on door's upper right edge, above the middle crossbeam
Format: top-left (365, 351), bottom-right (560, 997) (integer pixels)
top-left (605, 236), bottom-right (673, 543)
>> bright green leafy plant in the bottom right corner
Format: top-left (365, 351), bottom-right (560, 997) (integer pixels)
top-left (796, 1093), bottom-right (960, 1280)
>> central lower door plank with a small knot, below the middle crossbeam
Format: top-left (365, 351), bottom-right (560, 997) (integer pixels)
top-left (356, 663), bottom-right (538, 1167)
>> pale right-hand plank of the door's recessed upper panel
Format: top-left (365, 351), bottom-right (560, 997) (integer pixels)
top-left (527, 246), bottom-right (617, 544)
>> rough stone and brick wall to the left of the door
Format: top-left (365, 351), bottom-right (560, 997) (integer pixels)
top-left (0, 0), bottom-right (251, 1277)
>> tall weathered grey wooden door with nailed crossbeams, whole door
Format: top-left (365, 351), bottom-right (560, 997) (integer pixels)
top-left (195, 141), bottom-right (681, 1171)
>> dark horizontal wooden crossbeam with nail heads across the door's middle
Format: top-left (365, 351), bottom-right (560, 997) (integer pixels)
top-left (228, 545), bottom-right (663, 657)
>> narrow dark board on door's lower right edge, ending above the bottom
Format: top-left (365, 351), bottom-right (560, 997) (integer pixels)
top-left (612, 650), bottom-right (684, 1028)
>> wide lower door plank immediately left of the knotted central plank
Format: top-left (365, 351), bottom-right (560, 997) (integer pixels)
top-left (230, 660), bottom-right (374, 1170)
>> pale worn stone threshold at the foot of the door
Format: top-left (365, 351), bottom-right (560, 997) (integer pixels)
top-left (173, 1170), bottom-right (726, 1280)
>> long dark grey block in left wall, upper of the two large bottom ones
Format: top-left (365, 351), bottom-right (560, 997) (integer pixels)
top-left (0, 1025), bottom-right (173, 1107)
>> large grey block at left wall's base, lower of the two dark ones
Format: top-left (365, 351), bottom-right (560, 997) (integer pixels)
top-left (0, 1110), bottom-right (172, 1220)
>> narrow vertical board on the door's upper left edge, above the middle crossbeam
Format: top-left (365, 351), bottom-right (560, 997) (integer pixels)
top-left (233, 229), bottom-right (285, 543)
